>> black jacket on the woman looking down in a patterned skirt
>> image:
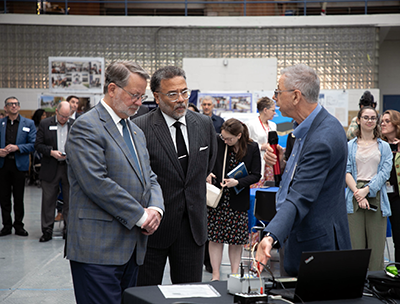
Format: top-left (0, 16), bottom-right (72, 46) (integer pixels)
top-left (213, 136), bottom-right (261, 211)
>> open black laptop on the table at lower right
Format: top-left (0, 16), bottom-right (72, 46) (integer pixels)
top-left (269, 249), bottom-right (371, 302)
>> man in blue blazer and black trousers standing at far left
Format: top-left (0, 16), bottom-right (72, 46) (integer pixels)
top-left (0, 97), bottom-right (36, 236)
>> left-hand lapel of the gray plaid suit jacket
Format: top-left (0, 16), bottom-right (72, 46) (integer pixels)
top-left (97, 103), bottom-right (143, 184)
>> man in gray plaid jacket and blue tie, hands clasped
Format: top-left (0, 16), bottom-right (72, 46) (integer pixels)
top-left (66, 61), bottom-right (164, 304)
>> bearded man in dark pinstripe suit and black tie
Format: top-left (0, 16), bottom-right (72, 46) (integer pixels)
top-left (133, 66), bottom-right (217, 285)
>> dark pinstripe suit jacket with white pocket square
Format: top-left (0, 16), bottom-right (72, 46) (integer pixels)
top-left (133, 108), bottom-right (217, 248)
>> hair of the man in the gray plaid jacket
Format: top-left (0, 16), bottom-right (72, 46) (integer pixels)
top-left (103, 60), bottom-right (150, 94)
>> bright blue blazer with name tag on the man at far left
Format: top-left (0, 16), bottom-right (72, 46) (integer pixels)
top-left (0, 115), bottom-right (36, 171)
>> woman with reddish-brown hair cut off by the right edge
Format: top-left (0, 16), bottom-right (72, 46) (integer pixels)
top-left (381, 110), bottom-right (400, 263)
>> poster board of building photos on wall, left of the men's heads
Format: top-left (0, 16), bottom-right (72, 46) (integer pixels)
top-left (49, 57), bottom-right (104, 94)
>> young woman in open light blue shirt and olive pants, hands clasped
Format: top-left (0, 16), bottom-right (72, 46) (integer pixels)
top-left (346, 106), bottom-right (393, 271)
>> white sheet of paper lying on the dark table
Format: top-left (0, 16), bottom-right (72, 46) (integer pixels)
top-left (158, 284), bottom-right (221, 299)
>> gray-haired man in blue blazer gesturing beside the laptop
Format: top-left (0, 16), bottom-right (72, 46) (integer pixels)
top-left (257, 64), bottom-right (351, 276)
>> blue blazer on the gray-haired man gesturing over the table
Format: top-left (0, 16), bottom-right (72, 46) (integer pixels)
top-left (265, 108), bottom-right (351, 276)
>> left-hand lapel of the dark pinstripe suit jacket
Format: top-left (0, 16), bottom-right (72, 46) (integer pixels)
top-left (151, 108), bottom-right (186, 179)
